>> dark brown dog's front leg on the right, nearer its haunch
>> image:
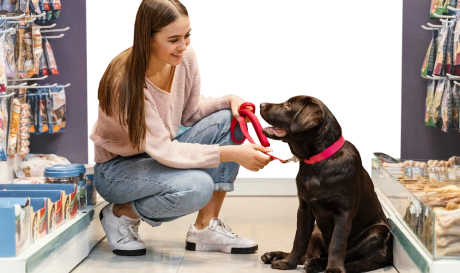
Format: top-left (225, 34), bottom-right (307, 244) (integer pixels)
top-left (324, 210), bottom-right (353, 273)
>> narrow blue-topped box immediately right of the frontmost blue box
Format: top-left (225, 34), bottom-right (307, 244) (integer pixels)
top-left (29, 198), bottom-right (50, 244)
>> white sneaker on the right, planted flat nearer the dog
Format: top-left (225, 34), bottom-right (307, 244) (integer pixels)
top-left (185, 217), bottom-right (258, 254)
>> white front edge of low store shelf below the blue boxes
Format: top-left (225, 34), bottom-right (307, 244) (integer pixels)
top-left (0, 198), bottom-right (108, 273)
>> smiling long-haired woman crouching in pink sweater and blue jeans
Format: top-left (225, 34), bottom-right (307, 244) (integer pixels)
top-left (90, 0), bottom-right (270, 256)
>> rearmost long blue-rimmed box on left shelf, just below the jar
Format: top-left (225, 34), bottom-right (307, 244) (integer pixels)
top-left (0, 184), bottom-right (78, 224)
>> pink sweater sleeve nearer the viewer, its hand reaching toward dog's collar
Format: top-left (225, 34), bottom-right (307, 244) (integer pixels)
top-left (144, 100), bottom-right (220, 169)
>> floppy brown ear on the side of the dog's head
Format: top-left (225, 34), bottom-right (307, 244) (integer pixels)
top-left (290, 98), bottom-right (325, 133)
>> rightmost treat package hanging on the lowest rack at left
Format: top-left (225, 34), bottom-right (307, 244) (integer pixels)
top-left (48, 87), bottom-right (66, 134)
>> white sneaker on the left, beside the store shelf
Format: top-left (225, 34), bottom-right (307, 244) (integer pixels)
top-left (99, 203), bottom-right (146, 256)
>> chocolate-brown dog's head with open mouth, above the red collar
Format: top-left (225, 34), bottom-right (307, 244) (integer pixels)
top-left (260, 95), bottom-right (341, 158)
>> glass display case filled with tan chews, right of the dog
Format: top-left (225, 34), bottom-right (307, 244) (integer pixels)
top-left (371, 156), bottom-right (460, 260)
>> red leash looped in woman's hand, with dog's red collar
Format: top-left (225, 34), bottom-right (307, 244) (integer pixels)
top-left (231, 101), bottom-right (345, 164)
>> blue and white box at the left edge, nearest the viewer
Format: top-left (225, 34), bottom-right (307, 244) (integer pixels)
top-left (0, 198), bottom-right (32, 257)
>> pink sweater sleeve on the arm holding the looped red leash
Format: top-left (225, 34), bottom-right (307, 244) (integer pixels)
top-left (181, 47), bottom-right (230, 127)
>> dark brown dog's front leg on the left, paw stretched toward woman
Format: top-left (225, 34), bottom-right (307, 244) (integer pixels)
top-left (262, 199), bottom-right (315, 270)
